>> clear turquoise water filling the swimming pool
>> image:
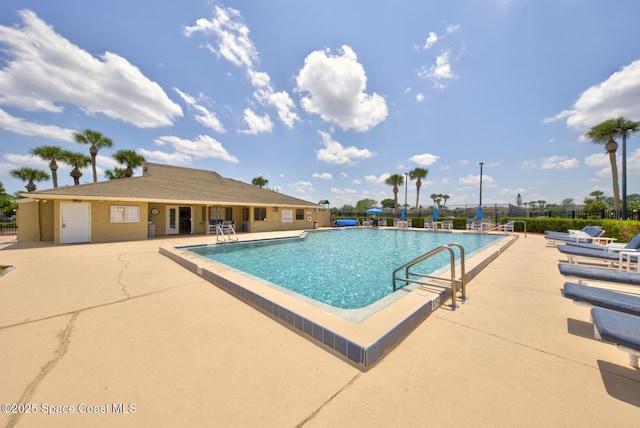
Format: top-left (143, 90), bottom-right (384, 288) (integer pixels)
top-left (188, 229), bottom-right (503, 309)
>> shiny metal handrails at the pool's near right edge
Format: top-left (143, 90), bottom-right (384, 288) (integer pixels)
top-left (393, 242), bottom-right (467, 310)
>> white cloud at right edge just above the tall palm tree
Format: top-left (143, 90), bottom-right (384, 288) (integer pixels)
top-left (544, 60), bottom-right (640, 131)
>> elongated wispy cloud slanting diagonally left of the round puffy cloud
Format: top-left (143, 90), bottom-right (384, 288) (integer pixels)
top-left (184, 6), bottom-right (300, 129)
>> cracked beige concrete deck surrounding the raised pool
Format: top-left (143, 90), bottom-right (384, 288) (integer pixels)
top-left (0, 229), bottom-right (640, 427)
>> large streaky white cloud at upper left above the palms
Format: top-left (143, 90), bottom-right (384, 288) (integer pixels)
top-left (0, 10), bottom-right (182, 128)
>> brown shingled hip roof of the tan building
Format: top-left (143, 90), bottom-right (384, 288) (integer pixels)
top-left (24, 162), bottom-right (320, 208)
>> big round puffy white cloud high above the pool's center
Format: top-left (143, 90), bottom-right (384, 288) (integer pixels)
top-left (296, 45), bottom-right (388, 131)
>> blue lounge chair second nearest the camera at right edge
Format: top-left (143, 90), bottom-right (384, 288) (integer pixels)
top-left (562, 282), bottom-right (640, 316)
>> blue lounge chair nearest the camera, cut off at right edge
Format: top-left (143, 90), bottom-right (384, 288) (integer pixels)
top-left (591, 307), bottom-right (640, 369)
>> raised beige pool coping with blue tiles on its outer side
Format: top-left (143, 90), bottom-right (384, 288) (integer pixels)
top-left (159, 229), bottom-right (518, 371)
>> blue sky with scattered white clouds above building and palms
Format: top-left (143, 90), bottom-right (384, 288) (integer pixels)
top-left (0, 0), bottom-right (640, 207)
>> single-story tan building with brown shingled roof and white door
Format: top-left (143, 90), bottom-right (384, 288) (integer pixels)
top-left (16, 162), bottom-right (330, 244)
